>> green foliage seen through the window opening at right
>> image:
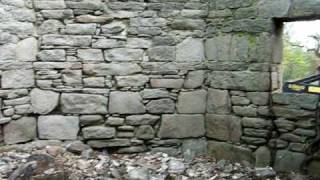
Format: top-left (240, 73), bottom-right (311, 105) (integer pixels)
top-left (282, 37), bottom-right (317, 82)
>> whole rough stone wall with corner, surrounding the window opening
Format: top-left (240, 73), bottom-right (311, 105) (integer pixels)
top-left (0, 0), bottom-right (320, 179)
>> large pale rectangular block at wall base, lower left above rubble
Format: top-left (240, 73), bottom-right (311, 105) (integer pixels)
top-left (38, 115), bottom-right (79, 140)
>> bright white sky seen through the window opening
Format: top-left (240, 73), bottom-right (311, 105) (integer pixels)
top-left (285, 20), bottom-right (320, 49)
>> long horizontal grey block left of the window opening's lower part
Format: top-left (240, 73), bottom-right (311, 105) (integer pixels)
top-left (209, 71), bottom-right (271, 91)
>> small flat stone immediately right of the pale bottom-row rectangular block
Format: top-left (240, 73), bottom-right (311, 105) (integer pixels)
top-left (82, 126), bottom-right (116, 139)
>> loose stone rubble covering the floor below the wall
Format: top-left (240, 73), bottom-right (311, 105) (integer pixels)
top-left (0, 141), bottom-right (308, 180)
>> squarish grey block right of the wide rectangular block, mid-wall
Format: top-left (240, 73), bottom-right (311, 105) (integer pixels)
top-left (109, 91), bottom-right (146, 114)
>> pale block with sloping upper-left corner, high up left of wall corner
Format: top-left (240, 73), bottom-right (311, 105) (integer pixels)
top-left (176, 38), bottom-right (205, 62)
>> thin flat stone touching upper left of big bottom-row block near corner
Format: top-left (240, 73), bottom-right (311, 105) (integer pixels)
top-left (126, 114), bottom-right (160, 126)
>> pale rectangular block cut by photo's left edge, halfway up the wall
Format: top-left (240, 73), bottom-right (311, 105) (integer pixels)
top-left (1, 69), bottom-right (35, 88)
